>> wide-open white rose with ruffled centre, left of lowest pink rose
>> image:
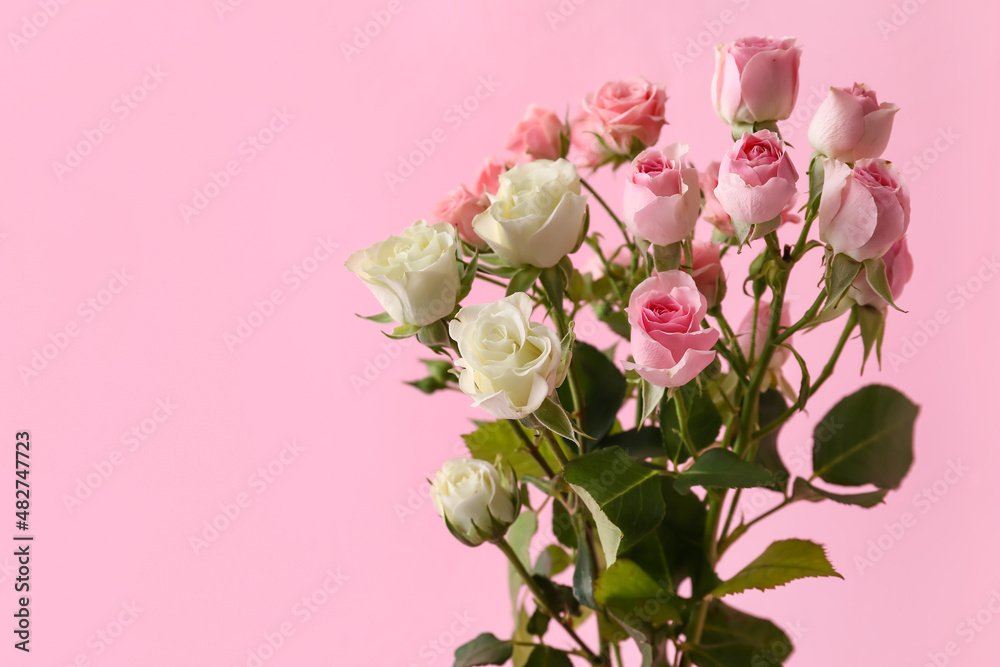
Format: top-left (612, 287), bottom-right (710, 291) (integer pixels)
top-left (448, 292), bottom-right (565, 419)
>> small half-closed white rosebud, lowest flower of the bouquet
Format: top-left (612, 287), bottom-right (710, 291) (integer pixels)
top-left (431, 458), bottom-right (517, 547)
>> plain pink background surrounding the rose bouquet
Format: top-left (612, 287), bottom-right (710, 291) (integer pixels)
top-left (0, 0), bottom-right (1000, 667)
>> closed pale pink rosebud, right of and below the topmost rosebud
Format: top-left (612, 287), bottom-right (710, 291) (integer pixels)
top-left (809, 83), bottom-right (899, 162)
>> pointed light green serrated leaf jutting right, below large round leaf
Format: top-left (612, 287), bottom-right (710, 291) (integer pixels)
top-left (712, 540), bottom-right (843, 597)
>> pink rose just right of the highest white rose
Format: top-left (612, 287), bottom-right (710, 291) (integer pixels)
top-left (625, 144), bottom-right (701, 245)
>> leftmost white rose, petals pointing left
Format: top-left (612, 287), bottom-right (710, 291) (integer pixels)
top-left (347, 220), bottom-right (461, 326)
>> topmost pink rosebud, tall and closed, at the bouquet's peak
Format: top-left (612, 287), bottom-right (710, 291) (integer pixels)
top-left (712, 37), bottom-right (802, 124)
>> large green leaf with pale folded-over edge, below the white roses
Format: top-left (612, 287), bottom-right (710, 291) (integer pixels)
top-left (563, 447), bottom-right (664, 565)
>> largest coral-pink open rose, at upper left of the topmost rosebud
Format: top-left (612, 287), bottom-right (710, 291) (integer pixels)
top-left (583, 76), bottom-right (667, 155)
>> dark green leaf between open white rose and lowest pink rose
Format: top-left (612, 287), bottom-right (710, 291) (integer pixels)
top-left (559, 341), bottom-right (628, 451)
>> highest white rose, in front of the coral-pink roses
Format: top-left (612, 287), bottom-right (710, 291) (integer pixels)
top-left (472, 158), bottom-right (587, 269)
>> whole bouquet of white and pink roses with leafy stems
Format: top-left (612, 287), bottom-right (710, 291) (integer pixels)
top-left (347, 37), bottom-right (918, 667)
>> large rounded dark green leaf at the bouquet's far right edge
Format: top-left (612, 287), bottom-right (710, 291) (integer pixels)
top-left (813, 384), bottom-right (920, 489)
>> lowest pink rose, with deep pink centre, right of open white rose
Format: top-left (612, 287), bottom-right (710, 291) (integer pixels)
top-left (624, 271), bottom-right (719, 387)
